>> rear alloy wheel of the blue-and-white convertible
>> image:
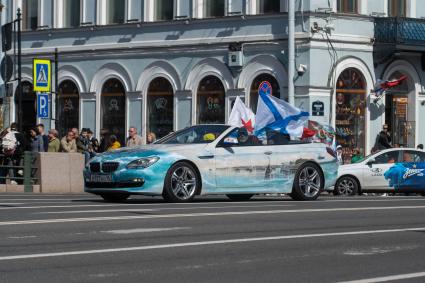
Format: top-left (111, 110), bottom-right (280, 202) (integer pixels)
top-left (290, 163), bottom-right (324, 201)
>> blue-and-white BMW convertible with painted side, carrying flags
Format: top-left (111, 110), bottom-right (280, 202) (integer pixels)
top-left (84, 125), bottom-right (338, 202)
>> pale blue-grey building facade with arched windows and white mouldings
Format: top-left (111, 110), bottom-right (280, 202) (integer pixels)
top-left (3, 0), bottom-right (425, 160)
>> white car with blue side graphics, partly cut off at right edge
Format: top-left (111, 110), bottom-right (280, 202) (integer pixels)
top-left (334, 148), bottom-right (425, 195)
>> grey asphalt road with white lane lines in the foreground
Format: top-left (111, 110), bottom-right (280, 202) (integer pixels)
top-left (0, 194), bottom-right (425, 283)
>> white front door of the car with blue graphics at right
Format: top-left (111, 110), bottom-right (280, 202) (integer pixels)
top-left (363, 150), bottom-right (400, 190)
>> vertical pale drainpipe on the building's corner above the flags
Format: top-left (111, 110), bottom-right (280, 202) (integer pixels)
top-left (288, 0), bottom-right (295, 105)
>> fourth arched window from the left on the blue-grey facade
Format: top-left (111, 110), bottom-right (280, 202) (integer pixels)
top-left (147, 78), bottom-right (174, 138)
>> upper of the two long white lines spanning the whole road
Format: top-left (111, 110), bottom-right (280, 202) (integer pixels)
top-left (0, 206), bottom-right (425, 226)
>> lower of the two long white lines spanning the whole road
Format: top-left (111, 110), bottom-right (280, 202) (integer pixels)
top-left (0, 227), bottom-right (425, 261)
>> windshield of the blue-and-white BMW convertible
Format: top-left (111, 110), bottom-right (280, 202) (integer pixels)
top-left (155, 125), bottom-right (229, 144)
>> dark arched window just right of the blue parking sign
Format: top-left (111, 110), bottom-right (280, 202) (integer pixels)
top-left (56, 80), bottom-right (80, 137)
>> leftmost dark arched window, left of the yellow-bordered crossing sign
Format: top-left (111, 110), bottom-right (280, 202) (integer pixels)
top-left (15, 82), bottom-right (37, 132)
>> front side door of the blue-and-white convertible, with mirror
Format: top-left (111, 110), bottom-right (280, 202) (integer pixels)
top-left (214, 129), bottom-right (271, 191)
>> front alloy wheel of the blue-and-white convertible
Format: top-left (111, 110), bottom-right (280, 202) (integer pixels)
top-left (162, 162), bottom-right (201, 202)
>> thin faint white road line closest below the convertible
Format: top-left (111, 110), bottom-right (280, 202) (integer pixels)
top-left (32, 204), bottom-right (293, 214)
